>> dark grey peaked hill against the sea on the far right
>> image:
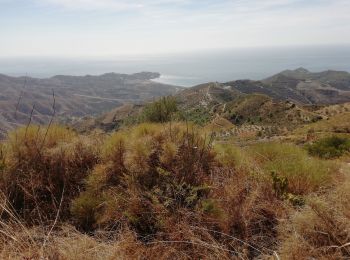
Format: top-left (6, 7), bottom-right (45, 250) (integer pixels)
top-left (224, 68), bottom-right (350, 105)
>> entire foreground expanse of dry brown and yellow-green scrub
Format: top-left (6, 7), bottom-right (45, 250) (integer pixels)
top-left (0, 119), bottom-right (350, 259)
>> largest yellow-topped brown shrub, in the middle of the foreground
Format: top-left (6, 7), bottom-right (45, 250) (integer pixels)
top-left (71, 123), bottom-right (215, 234)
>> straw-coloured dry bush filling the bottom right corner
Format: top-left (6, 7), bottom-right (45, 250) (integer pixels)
top-left (279, 176), bottom-right (350, 259)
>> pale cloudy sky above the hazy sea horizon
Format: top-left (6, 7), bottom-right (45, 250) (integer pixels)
top-left (0, 0), bottom-right (350, 56)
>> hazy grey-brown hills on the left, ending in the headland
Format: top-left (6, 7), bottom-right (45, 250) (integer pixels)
top-left (0, 72), bottom-right (181, 136)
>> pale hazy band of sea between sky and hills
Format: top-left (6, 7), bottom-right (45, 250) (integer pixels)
top-left (0, 46), bottom-right (350, 86)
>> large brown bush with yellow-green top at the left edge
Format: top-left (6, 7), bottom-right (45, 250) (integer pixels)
top-left (0, 126), bottom-right (98, 223)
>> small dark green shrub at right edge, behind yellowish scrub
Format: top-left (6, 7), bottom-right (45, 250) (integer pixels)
top-left (306, 136), bottom-right (350, 159)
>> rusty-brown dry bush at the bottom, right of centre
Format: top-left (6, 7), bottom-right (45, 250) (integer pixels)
top-left (211, 171), bottom-right (288, 259)
